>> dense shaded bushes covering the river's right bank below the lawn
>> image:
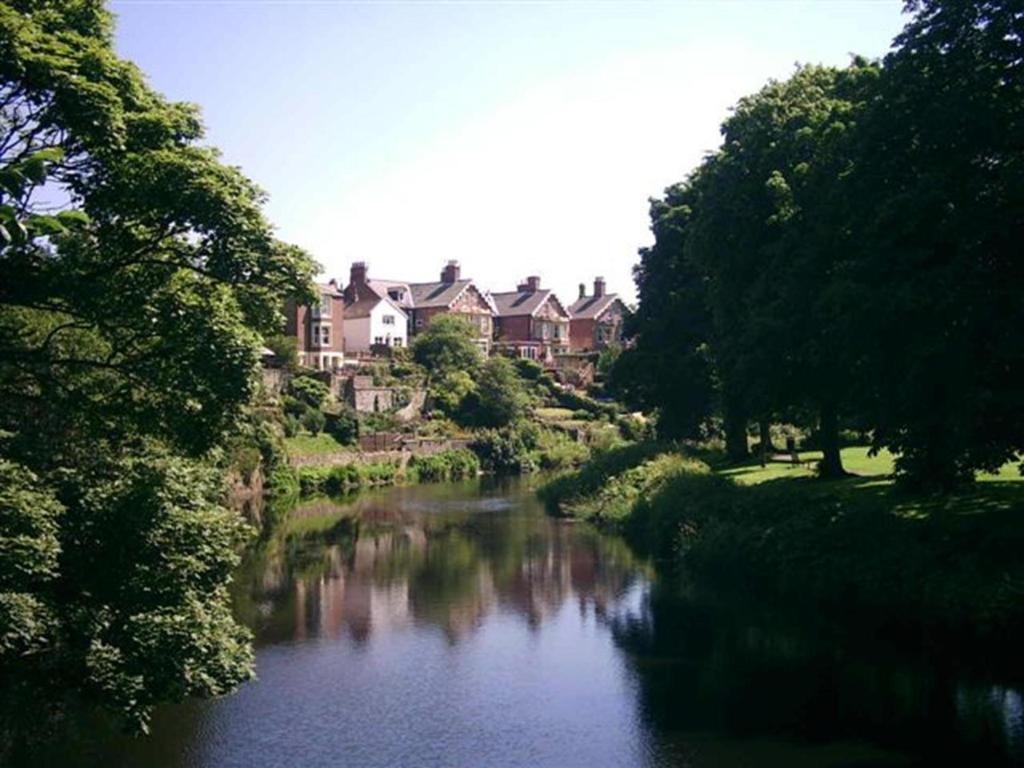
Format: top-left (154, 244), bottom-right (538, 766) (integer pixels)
top-left (540, 445), bottom-right (1024, 632)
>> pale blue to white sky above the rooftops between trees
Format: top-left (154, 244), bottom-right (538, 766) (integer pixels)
top-left (109, 0), bottom-right (905, 302)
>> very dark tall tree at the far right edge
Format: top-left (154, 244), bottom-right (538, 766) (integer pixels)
top-left (839, 0), bottom-right (1024, 487)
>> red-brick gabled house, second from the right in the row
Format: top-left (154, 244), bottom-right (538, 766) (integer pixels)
top-left (490, 275), bottom-right (570, 362)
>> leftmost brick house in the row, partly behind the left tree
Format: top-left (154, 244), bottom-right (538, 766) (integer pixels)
top-left (285, 280), bottom-right (345, 371)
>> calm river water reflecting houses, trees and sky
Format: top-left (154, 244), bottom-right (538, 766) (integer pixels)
top-left (31, 483), bottom-right (1024, 768)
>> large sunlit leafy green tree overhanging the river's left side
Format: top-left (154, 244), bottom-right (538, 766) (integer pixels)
top-left (0, 0), bottom-right (314, 741)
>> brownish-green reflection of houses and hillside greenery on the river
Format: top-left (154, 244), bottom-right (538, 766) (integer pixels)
top-left (236, 485), bottom-right (638, 643)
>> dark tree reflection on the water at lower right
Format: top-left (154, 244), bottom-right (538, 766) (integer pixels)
top-left (611, 582), bottom-right (1024, 766)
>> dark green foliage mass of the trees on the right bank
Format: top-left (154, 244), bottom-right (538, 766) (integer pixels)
top-left (610, 0), bottom-right (1024, 488)
